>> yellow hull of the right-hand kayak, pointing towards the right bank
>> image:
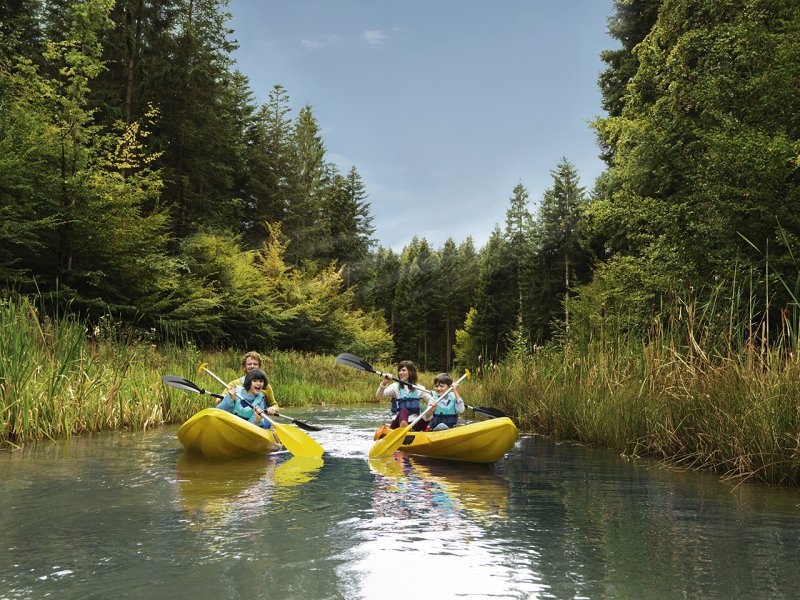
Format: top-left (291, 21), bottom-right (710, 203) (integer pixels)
top-left (386, 417), bottom-right (519, 462)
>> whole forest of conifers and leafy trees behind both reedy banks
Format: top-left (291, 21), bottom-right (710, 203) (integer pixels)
top-left (0, 0), bottom-right (800, 370)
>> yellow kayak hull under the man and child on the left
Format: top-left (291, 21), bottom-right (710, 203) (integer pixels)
top-left (178, 408), bottom-right (282, 458)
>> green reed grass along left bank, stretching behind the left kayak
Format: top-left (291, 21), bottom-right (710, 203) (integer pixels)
top-left (0, 297), bottom-right (382, 447)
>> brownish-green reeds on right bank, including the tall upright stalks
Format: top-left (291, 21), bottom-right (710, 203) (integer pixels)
top-left (476, 268), bottom-right (800, 485)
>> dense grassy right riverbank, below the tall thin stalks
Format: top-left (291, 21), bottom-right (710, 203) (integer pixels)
top-left (469, 345), bottom-right (800, 486)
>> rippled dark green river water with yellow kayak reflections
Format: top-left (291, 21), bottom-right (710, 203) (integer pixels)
top-left (0, 405), bottom-right (800, 600)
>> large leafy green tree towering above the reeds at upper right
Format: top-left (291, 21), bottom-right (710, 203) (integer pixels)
top-left (590, 0), bottom-right (800, 328)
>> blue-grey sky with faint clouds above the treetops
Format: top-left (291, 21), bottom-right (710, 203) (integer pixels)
top-left (228, 0), bottom-right (619, 252)
